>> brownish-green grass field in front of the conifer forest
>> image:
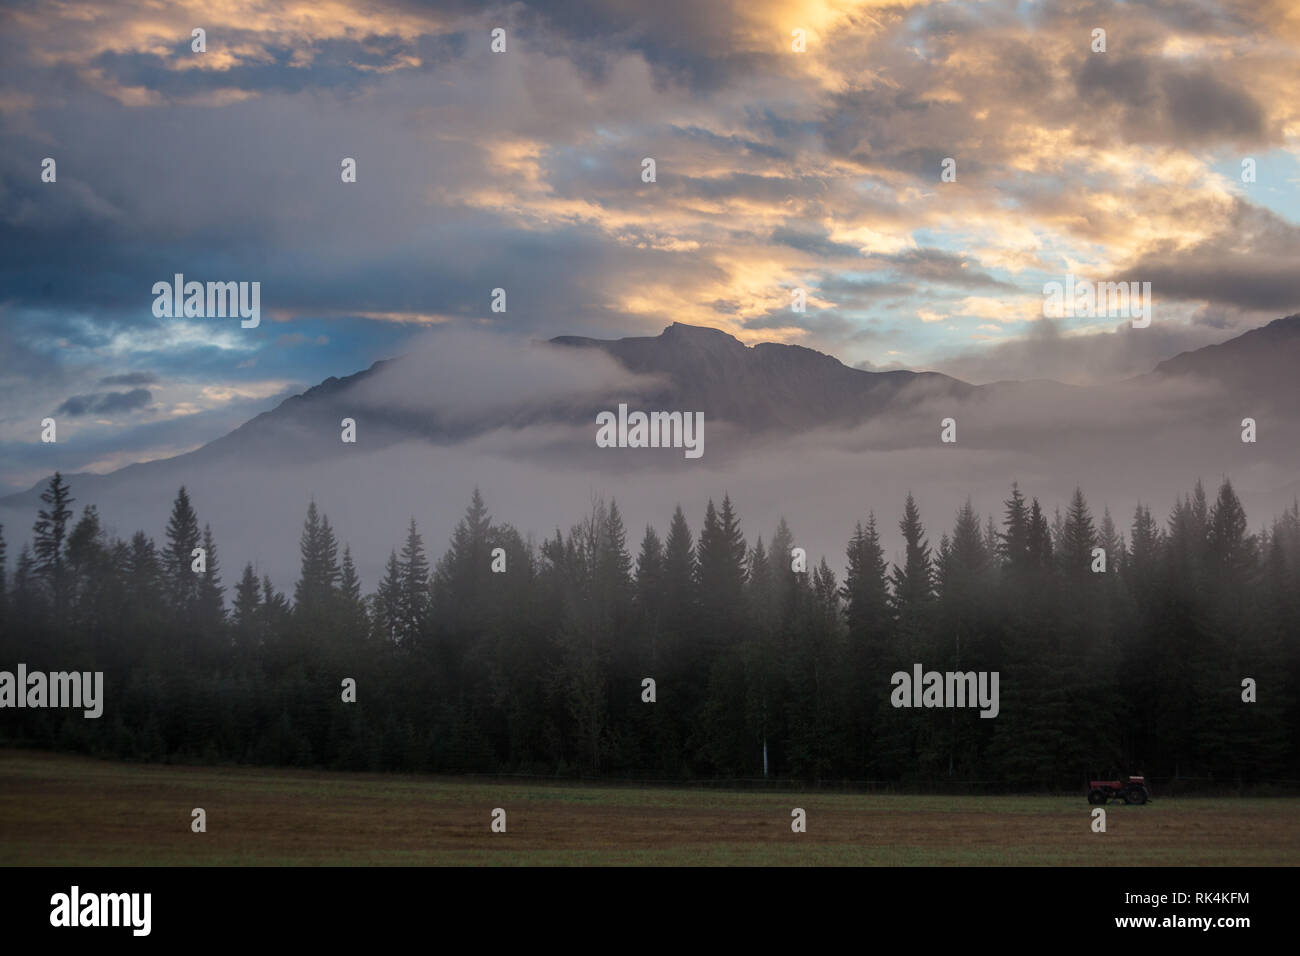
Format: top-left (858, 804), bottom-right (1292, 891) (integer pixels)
top-left (0, 750), bottom-right (1300, 866)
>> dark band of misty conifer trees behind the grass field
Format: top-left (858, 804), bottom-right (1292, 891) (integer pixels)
top-left (0, 475), bottom-right (1300, 788)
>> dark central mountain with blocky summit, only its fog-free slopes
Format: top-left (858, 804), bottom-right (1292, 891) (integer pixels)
top-left (0, 323), bottom-right (987, 507)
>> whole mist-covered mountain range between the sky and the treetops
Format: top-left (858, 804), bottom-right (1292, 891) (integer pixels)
top-left (0, 316), bottom-right (1300, 587)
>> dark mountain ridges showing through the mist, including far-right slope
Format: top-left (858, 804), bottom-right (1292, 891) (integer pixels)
top-left (0, 313), bottom-right (1300, 505)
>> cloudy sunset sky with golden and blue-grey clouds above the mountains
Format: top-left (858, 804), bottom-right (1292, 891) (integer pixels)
top-left (0, 0), bottom-right (1300, 490)
